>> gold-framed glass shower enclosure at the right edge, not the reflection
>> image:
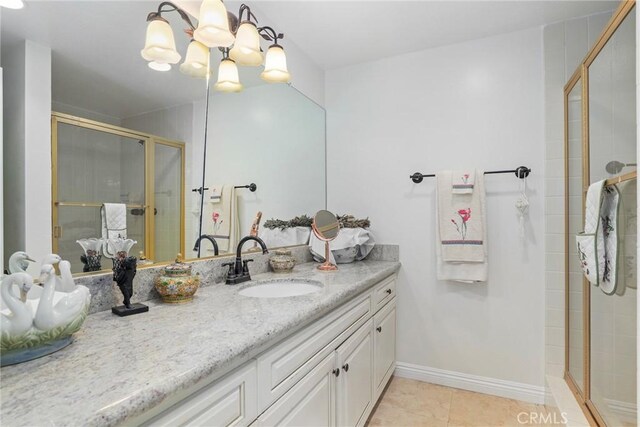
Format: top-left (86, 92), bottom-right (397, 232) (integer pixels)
top-left (565, 1), bottom-right (638, 426)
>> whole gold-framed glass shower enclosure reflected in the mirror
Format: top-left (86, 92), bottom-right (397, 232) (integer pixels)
top-left (51, 113), bottom-right (185, 273)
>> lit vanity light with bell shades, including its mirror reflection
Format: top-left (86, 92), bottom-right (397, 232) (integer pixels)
top-left (141, 0), bottom-right (291, 92)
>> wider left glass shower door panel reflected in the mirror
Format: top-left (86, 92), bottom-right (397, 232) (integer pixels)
top-left (52, 116), bottom-right (147, 273)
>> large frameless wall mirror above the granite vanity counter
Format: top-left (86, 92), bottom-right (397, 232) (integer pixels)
top-left (0, 1), bottom-right (326, 273)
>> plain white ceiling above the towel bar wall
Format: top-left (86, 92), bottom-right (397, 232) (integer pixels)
top-left (252, 0), bottom-right (619, 70)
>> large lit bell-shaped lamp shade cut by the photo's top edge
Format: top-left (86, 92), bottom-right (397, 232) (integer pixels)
top-left (193, 0), bottom-right (234, 47)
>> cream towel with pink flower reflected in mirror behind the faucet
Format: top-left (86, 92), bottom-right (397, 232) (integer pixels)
top-left (202, 184), bottom-right (240, 252)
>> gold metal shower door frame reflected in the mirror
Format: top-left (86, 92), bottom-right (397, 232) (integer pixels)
top-left (51, 112), bottom-right (185, 266)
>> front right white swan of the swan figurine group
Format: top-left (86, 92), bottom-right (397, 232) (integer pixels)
top-left (33, 264), bottom-right (91, 331)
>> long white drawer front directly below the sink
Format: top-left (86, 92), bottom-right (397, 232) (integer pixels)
top-left (257, 293), bottom-right (371, 412)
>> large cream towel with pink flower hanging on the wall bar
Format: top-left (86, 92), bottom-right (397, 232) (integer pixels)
top-left (436, 171), bottom-right (486, 262)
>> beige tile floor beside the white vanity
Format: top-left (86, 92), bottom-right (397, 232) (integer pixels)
top-left (368, 377), bottom-right (561, 427)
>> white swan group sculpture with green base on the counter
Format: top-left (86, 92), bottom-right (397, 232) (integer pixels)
top-left (0, 255), bottom-right (91, 366)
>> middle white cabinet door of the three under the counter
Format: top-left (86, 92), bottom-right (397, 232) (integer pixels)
top-left (336, 320), bottom-right (373, 426)
